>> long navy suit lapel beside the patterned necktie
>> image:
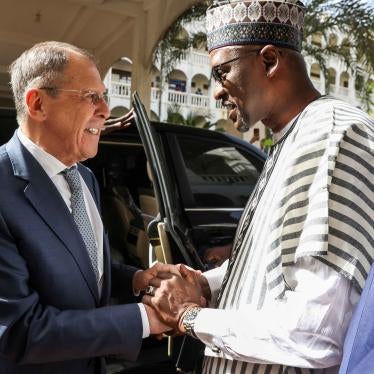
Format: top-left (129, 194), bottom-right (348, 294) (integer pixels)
top-left (7, 134), bottom-right (99, 303)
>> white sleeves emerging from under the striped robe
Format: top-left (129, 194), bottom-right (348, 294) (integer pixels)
top-left (199, 257), bottom-right (359, 373)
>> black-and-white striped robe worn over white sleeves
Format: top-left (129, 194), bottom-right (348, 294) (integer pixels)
top-left (203, 96), bottom-right (374, 374)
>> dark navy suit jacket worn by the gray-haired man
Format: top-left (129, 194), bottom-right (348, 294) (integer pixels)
top-left (0, 134), bottom-right (142, 374)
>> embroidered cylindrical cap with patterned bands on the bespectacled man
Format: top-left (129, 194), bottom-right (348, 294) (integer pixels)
top-left (206, 0), bottom-right (305, 52)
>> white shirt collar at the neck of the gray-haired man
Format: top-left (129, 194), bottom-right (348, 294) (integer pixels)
top-left (17, 128), bottom-right (76, 178)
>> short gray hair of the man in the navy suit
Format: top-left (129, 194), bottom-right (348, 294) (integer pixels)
top-left (9, 41), bottom-right (96, 124)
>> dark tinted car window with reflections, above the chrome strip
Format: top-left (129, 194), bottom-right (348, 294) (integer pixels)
top-left (178, 136), bottom-right (260, 208)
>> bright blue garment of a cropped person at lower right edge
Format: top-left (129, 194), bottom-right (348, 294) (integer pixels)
top-left (339, 266), bottom-right (374, 374)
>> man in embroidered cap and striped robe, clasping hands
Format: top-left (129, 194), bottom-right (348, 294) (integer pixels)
top-left (144, 1), bottom-right (374, 374)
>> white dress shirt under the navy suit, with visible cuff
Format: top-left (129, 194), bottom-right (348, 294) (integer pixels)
top-left (17, 128), bottom-right (150, 338)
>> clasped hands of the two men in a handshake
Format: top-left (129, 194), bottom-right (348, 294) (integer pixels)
top-left (133, 263), bottom-right (211, 336)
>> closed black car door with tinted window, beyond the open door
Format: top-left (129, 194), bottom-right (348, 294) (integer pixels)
top-left (164, 128), bottom-right (265, 268)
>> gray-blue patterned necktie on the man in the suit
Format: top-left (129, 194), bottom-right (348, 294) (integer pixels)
top-left (62, 166), bottom-right (99, 282)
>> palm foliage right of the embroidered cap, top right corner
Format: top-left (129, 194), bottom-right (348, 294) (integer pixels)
top-left (303, 0), bottom-right (374, 110)
